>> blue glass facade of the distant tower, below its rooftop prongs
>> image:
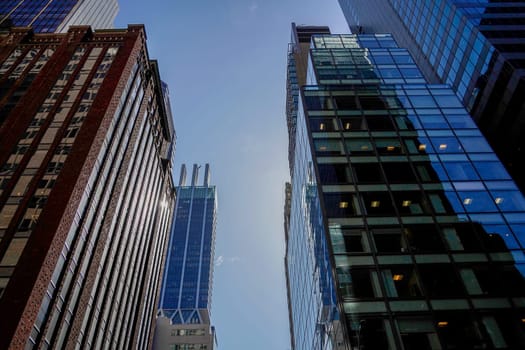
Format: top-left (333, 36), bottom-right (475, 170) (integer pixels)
top-left (159, 186), bottom-right (216, 323)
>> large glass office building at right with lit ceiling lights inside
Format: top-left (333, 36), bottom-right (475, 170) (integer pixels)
top-left (285, 23), bottom-right (525, 350)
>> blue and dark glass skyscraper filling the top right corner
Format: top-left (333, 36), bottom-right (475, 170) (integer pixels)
top-left (339, 0), bottom-right (525, 193)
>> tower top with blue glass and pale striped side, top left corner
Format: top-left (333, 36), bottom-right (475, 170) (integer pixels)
top-left (0, 0), bottom-right (118, 33)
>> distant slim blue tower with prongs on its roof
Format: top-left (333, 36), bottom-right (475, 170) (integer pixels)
top-left (153, 164), bottom-right (217, 350)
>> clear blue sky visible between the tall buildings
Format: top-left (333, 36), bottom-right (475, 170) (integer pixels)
top-left (116, 0), bottom-right (348, 350)
